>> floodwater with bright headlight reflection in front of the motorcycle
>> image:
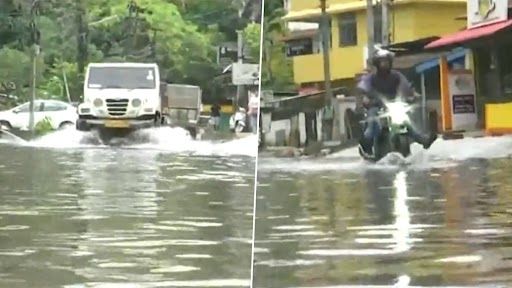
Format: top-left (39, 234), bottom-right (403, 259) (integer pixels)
top-left (254, 137), bottom-right (512, 287)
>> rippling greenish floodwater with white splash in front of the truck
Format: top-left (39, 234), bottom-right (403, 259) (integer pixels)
top-left (0, 128), bottom-right (257, 288)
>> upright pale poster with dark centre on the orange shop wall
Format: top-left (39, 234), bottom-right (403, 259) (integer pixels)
top-left (448, 70), bottom-right (478, 130)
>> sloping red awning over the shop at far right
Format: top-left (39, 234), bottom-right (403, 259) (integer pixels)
top-left (425, 20), bottom-right (512, 49)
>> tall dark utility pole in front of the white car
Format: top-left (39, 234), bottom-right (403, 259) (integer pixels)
top-left (28, 0), bottom-right (41, 136)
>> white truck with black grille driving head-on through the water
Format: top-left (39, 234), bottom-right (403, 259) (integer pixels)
top-left (76, 63), bottom-right (162, 143)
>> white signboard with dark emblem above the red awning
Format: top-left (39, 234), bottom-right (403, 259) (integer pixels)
top-left (467, 0), bottom-right (509, 29)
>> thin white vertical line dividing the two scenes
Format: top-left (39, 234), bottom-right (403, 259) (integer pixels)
top-left (250, 0), bottom-right (265, 288)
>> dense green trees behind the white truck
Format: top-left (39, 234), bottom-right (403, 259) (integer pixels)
top-left (0, 0), bottom-right (259, 102)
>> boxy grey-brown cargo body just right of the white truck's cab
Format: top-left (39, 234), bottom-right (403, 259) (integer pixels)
top-left (160, 83), bottom-right (202, 138)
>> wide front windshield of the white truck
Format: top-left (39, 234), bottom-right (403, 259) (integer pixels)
top-left (87, 67), bottom-right (156, 89)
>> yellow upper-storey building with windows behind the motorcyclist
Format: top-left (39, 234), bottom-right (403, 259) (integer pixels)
top-left (284, 0), bottom-right (466, 88)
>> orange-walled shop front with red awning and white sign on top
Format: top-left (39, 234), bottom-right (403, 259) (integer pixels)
top-left (426, 0), bottom-right (512, 134)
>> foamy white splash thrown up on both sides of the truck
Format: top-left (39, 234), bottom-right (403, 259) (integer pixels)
top-left (2, 127), bottom-right (258, 157)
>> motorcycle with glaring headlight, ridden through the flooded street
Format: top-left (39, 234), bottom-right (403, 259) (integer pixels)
top-left (359, 98), bottom-right (412, 162)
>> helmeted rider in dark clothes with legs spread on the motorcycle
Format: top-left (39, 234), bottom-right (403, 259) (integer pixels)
top-left (357, 47), bottom-right (437, 156)
